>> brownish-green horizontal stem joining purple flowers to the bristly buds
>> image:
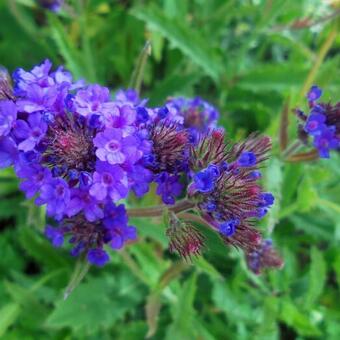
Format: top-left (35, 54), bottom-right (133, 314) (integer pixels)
top-left (127, 199), bottom-right (195, 217)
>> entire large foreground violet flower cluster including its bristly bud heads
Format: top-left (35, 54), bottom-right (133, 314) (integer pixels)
top-left (0, 60), bottom-right (282, 266)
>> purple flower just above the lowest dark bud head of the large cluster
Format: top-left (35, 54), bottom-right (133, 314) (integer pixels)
top-left (67, 189), bottom-right (104, 222)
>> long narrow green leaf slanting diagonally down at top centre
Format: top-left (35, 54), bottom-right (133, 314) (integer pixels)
top-left (131, 6), bottom-right (222, 80)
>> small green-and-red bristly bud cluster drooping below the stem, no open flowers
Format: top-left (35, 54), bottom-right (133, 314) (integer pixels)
top-left (166, 215), bottom-right (205, 260)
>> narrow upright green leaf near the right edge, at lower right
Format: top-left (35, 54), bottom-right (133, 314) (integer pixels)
top-left (304, 247), bottom-right (327, 309)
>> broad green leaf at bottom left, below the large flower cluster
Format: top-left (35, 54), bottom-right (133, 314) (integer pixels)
top-left (46, 272), bottom-right (143, 334)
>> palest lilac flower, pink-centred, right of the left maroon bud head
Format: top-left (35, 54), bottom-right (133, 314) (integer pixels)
top-left (93, 129), bottom-right (143, 164)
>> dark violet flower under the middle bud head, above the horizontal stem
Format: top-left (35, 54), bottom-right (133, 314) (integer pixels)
top-left (155, 172), bottom-right (183, 204)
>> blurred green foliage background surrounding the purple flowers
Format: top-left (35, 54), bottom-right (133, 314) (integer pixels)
top-left (0, 0), bottom-right (340, 340)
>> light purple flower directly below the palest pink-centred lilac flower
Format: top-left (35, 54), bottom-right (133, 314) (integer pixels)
top-left (90, 162), bottom-right (128, 202)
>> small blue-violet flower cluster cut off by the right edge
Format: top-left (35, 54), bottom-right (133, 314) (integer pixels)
top-left (297, 85), bottom-right (340, 158)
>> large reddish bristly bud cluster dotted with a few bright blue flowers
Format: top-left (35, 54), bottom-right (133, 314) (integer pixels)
top-left (188, 130), bottom-right (274, 251)
